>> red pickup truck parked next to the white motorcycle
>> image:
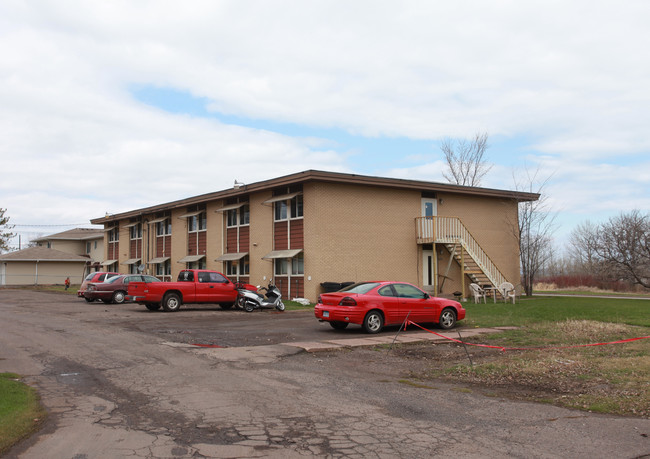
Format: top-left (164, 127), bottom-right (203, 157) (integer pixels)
top-left (128, 269), bottom-right (237, 311)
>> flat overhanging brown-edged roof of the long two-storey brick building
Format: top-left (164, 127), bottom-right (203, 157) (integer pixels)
top-left (90, 170), bottom-right (540, 225)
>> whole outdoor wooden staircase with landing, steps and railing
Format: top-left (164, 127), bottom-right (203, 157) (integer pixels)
top-left (415, 217), bottom-right (507, 287)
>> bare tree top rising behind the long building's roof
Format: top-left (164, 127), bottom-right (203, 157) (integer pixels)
top-left (440, 132), bottom-right (492, 186)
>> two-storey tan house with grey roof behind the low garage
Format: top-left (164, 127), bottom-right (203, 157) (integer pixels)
top-left (32, 228), bottom-right (104, 271)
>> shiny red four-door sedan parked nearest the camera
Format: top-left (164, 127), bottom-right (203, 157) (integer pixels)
top-left (314, 282), bottom-right (465, 333)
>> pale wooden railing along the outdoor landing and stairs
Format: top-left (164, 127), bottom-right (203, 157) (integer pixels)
top-left (415, 217), bottom-right (507, 287)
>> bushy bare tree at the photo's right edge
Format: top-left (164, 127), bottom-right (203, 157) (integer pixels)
top-left (596, 210), bottom-right (650, 288)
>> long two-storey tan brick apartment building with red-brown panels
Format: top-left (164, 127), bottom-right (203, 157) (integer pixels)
top-left (91, 170), bottom-right (539, 301)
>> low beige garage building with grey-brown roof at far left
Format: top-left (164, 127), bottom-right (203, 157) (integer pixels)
top-left (0, 247), bottom-right (88, 285)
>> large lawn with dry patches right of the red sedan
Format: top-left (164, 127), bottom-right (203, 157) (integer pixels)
top-left (421, 297), bottom-right (650, 417)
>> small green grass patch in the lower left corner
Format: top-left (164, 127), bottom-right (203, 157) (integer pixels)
top-left (0, 373), bottom-right (45, 455)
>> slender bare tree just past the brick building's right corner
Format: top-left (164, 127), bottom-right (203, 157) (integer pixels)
top-left (513, 168), bottom-right (556, 295)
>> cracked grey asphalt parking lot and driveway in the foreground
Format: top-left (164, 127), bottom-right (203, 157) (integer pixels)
top-left (0, 289), bottom-right (650, 459)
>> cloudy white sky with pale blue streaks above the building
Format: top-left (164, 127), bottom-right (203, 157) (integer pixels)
top-left (0, 0), bottom-right (650, 252)
